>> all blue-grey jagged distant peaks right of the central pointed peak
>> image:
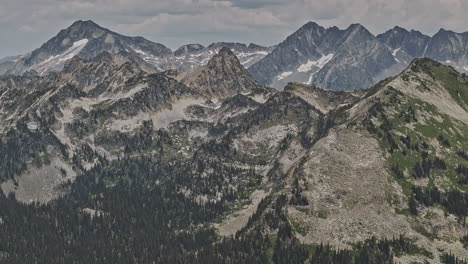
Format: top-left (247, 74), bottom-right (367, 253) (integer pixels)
top-left (249, 22), bottom-right (468, 90)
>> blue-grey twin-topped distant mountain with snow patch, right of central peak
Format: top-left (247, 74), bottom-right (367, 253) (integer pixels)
top-left (249, 22), bottom-right (399, 90)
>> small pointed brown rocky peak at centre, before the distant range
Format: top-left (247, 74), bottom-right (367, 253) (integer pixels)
top-left (182, 47), bottom-right (263, 97)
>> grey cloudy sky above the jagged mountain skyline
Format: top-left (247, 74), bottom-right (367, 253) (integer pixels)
top-left (0, 0), bottom-right (468, 58)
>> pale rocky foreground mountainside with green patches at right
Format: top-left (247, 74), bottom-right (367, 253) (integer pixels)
top-left (288, 59), bottom-right (468, 263)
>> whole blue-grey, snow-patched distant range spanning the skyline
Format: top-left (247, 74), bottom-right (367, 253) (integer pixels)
top-left (0, 21), bottom-right (468, 90)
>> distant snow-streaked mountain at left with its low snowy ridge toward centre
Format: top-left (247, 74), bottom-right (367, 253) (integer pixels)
top-left (0, 20), bottom-right (272, 75)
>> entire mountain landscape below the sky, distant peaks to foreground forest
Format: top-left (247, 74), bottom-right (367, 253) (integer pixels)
top-left (0, 21), bottom-right (468, 263)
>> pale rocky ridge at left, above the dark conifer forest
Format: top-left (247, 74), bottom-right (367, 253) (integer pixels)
top-left (0, 53), bottom-right (206, 202)
